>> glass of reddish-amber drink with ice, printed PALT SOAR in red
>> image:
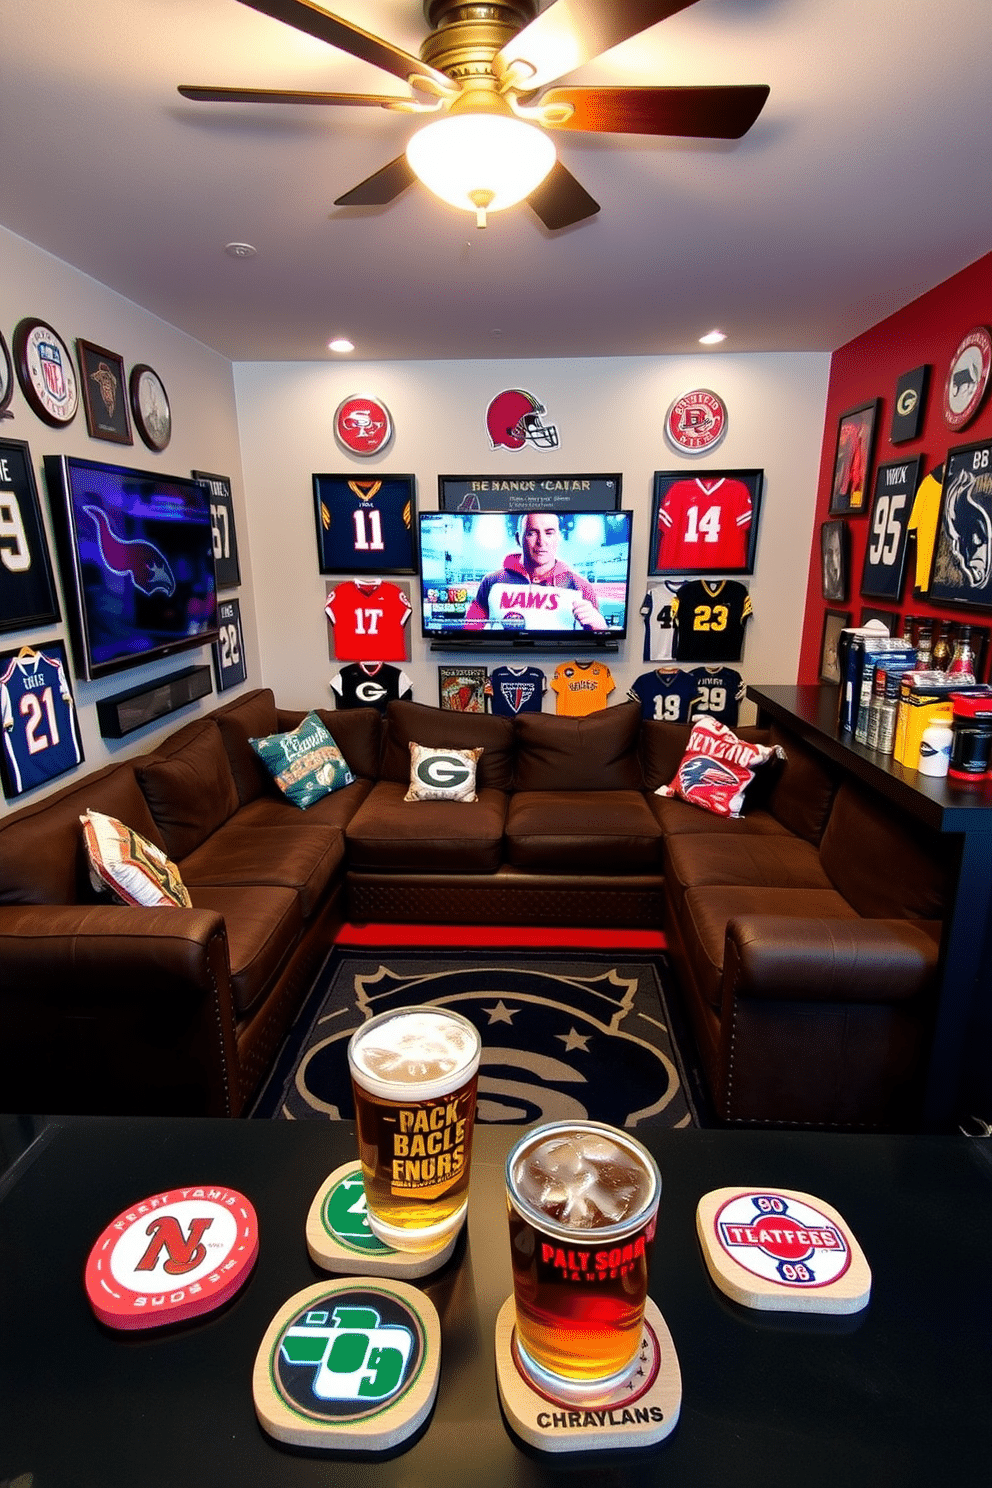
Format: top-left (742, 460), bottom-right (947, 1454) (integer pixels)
top-left (506, 1120), bottom-right (662, 1400)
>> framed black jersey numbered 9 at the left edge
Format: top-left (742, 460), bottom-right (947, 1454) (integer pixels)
top-left (0, 439), bottom-right (61, 631)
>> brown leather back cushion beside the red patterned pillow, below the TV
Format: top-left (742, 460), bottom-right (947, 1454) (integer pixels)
top-left (513, 702), bottom-right (644, 790)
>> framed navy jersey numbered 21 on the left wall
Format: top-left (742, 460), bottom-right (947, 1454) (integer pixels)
top-left (0, 641), bottom-right (83, 801)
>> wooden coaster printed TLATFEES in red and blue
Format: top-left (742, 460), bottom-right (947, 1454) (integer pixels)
top-left (696, 1189), bottom-right (872, 1312)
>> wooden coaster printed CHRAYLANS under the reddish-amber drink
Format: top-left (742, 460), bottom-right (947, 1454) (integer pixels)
top-left (495, 1296), bottom-right (683, 1452)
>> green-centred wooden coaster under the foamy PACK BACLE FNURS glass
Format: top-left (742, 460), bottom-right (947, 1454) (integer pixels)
top-left (306, 1162), bottom-right (461, 1281)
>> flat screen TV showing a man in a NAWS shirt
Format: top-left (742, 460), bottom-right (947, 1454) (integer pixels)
top-left (419, 512), bottom-right (631, 649)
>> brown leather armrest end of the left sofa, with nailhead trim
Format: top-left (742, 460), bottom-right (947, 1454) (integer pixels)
top-left (0, 905), bottom-right (238, 1116)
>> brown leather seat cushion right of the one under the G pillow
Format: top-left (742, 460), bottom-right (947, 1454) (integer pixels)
top-left (506, 790), bottom-right (662, 873)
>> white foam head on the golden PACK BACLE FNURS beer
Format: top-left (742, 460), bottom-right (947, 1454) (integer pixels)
top-left (348, 1007), bottom-right (480, 1101)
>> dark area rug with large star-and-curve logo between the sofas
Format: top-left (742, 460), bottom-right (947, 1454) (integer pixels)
top-left (251, 948), bottom-right (702, 1128)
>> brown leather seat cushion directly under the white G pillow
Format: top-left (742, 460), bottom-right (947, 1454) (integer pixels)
top-left (345, 779), bottom-right (506, 873)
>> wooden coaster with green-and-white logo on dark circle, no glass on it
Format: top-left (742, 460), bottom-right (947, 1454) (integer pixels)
top-left (251, 1277), bottom-right (440, 1452)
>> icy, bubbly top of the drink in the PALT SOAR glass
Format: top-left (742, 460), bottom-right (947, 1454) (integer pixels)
top-left (507, 1122), bottom-right (660, 1231)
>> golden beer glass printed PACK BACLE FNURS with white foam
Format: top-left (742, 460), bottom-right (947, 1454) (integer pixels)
top-left (348, 1007), bottom-right (482, 1251)
